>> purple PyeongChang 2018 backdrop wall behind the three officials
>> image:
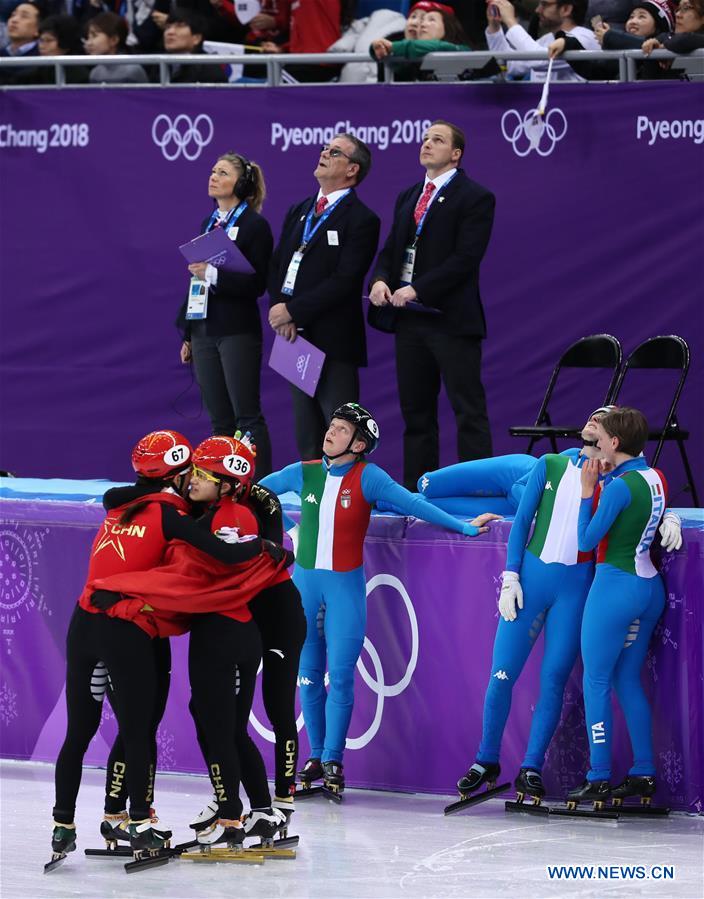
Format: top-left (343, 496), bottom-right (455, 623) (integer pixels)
top-left (0, 82), bottom-right (704, 505)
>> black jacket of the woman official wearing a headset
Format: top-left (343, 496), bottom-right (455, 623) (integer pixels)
top-left (176, 206), bottom-right (274, 339)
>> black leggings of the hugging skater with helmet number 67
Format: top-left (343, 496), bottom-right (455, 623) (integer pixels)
top-left (54, 606), bottom-right (157, 824)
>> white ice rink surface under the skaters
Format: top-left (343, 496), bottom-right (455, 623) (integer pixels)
top-left (0, 761), bottom-right (704, 899)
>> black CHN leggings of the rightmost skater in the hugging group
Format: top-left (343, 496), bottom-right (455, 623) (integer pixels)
top-left (249, 580), bottom-right (306, 807)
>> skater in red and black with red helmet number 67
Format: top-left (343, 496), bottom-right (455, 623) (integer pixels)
top-left (47, 431), bottom-right (272, 870)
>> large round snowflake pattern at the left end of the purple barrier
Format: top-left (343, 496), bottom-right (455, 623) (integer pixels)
top-left (0, 522), bottom-right (51, 655)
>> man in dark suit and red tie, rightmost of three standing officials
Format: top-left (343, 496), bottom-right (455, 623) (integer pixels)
top-left (369, 121), bottom-right (495, 490)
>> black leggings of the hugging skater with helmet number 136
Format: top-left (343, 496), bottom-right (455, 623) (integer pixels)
top-left (188, 614), bottom-right (262, 819)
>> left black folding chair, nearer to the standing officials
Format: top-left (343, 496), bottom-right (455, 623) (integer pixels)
top-left (508, 334), bottom-right (623, 453)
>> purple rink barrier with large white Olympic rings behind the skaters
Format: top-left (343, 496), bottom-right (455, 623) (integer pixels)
top-left (0, 500), bottom-right (704, 812)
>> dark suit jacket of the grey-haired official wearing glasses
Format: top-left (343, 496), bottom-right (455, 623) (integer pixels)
top-left (269, 190), bottom-right (380, 365)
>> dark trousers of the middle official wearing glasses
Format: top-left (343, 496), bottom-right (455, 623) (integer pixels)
top-left (290, 356), bottom-right (359, 460)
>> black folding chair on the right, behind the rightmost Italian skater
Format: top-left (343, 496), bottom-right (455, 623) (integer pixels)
top-left (611, 334), bottom-right (699, 506)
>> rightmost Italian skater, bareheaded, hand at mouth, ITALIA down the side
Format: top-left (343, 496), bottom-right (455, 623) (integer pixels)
top-left (567, 408), bottom-right (667, 805)
